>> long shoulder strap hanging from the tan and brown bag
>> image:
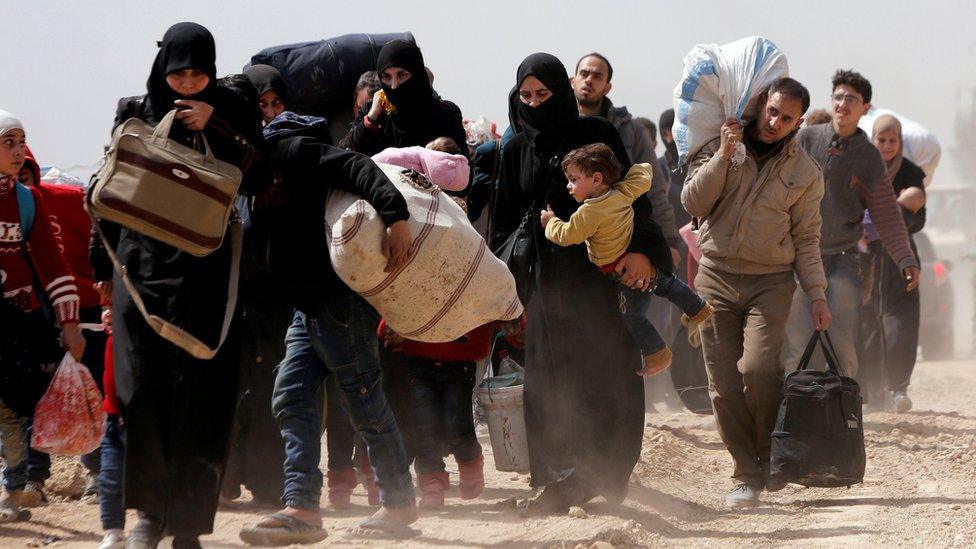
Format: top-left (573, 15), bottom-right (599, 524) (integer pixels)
top-left (88, 206), bottom-right (244, 360)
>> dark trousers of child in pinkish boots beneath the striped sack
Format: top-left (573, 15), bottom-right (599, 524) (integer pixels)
top-left (410, 357), bottom-right (481, 474)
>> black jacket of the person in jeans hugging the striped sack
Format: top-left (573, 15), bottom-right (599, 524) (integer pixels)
top-left (268, 136), bottom-right (410, 311)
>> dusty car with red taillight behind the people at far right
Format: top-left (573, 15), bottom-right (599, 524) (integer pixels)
top-left (915, 231), bottom-right (956, 360)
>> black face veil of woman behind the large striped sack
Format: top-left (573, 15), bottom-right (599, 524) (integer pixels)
top-left (376, 40), bottom-right (434, 118)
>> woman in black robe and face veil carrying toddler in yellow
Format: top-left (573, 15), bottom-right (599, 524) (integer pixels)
top-left (492, 53), bottom-right (671, 512)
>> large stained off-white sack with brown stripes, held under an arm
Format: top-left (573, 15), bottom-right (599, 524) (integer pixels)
top-left (325, 164), bottom-right (522, 343)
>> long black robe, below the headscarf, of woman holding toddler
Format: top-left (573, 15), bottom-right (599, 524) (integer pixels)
top-left (492, 118), bottom-right (671, 497)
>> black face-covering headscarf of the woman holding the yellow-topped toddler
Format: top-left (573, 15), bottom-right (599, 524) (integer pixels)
top-left (508, 53), bottom-right (579, 149)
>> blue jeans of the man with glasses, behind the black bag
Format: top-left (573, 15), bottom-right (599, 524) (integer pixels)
top-left (782, 248), bottom-right (861, 377)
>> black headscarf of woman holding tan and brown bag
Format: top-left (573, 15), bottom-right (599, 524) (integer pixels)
top-left (146, 23), bottom-right (217, 123)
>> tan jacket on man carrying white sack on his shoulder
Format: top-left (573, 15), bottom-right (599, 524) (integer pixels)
top-left (681, 135), bottom-right (827, 301)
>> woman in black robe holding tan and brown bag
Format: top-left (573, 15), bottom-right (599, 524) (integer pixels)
top-left (93, 23), bottom-right (266, 547)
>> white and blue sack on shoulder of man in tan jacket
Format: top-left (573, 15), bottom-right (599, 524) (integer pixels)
top-left (672, 36), bottom-right (790, 163)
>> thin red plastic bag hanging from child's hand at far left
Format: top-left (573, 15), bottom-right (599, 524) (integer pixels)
top-left (31, 353), bottom-right (105, 456)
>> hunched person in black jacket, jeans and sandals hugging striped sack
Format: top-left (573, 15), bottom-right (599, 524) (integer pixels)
top-left (241, 113), bottom-right (417, 545)
